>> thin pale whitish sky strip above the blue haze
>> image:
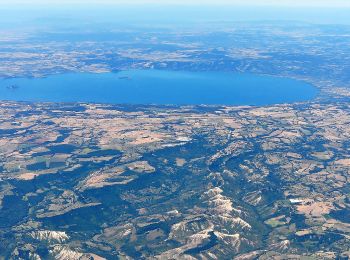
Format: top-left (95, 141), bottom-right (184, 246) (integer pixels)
top-left (0, 0), bottom-right (350, 7)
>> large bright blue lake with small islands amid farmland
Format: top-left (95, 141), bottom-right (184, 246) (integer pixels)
top-left (0, 70), bottom-right (318, 105)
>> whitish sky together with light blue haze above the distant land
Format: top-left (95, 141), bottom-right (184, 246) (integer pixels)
top-left (0, 0), bottom-right (350, 29)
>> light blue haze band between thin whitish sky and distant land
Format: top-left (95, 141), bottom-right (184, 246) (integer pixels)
top-left (0, 5), bottom-right (350, 27)
